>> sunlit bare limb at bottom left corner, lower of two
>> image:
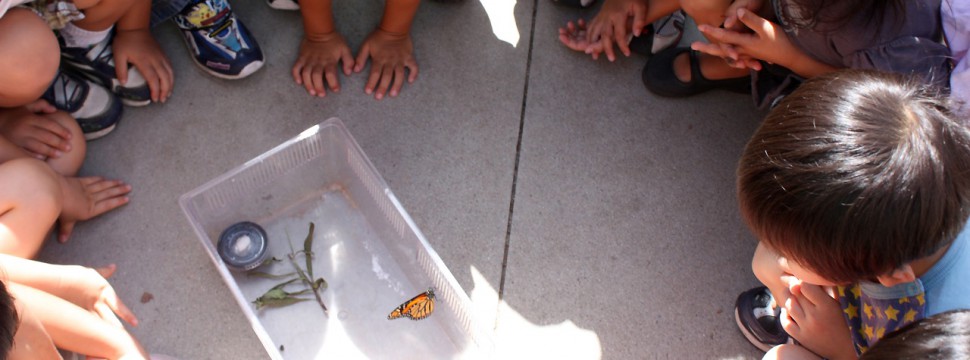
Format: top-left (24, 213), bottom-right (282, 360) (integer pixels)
top-left (8, 283), bottom-right (148, 359)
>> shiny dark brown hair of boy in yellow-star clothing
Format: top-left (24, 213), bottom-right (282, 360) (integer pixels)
top-left (737, 70), bottom-right (970, 283)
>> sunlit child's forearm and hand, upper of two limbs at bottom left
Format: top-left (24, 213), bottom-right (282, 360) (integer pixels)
top-left (0, 254), bottom-right (138, 326)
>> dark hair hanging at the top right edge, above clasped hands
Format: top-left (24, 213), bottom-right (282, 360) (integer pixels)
top-left (785, 0), bottom-right (907, 32)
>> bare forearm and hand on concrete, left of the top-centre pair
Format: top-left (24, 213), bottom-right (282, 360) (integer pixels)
top-left (292, 0), bottom-right (354, 97)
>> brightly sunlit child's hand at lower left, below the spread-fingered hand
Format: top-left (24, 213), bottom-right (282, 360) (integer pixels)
top-left (58, 264), bottom-right (138, 327)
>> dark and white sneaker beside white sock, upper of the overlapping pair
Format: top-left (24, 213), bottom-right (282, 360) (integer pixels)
top-left (59, 32), bottom-right (152, 106)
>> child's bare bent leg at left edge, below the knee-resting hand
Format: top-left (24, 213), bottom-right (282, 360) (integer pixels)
top-left (0, 158), bottom-right (61, 259)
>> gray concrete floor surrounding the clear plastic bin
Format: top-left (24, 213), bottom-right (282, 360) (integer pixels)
top-left (41, 0), bottom-right (763, 359)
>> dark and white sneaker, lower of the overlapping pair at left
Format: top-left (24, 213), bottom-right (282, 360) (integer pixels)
top-left (41, 68), bottom-right (122, 140)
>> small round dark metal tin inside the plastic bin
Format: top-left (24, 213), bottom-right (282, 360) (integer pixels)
top-left (217, 221), bottom-right (268, 271)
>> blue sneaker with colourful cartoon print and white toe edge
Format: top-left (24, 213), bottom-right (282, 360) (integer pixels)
top-left (175, 0), bottom-right (263, 79)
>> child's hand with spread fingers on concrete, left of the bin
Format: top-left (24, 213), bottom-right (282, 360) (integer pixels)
top-left (57, 176), bottom-right (131, 243)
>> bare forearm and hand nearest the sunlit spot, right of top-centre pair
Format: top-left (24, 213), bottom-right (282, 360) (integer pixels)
top-left (354, 0), bottom-right (421, 100)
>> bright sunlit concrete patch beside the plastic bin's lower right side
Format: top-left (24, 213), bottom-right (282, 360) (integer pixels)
top-left (471, 266), bottom-right (603, 359)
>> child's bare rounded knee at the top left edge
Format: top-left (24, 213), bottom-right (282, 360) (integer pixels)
top-left (0, 8), bottom-right (61, 107)
